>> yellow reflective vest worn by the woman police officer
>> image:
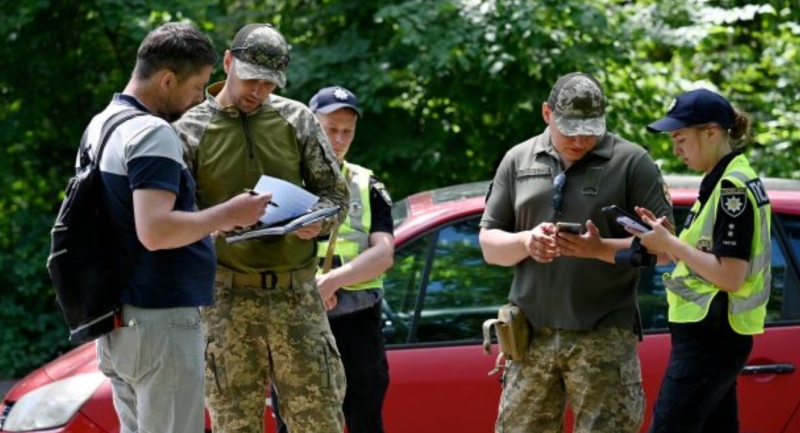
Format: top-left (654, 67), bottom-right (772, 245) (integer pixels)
top-left (663, 155), bottom-right (772, 335)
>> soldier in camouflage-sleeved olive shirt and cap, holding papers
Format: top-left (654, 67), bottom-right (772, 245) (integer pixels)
top-left (175, 24), bottom-right (349, 433)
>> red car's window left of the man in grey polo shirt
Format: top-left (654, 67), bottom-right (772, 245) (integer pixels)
top-left (384, 217), bottom-right (513, 344)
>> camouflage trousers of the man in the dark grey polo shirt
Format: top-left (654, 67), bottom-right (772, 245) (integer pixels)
top-left (495, 327), bottom-right (645, 433)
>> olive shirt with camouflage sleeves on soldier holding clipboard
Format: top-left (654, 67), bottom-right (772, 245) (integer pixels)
top-left (173, 82), bottom-right (350, 273)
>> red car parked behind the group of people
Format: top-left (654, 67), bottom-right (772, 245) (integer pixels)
top-left (0, 176), bottom-right (800, 433)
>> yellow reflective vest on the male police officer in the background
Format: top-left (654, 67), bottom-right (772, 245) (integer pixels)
top-left (317, 161), bottom-right (383, 290)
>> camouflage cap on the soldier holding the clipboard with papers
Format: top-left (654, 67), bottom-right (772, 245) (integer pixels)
top-left (230, 24), bottom-right (289, 87)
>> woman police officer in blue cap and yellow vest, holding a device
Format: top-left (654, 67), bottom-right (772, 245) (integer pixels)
top-left (629, 89), bottom-right (770, 433)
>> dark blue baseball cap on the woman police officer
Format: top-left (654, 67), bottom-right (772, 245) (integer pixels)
top-left (647, 89), bottom-right (736, 132)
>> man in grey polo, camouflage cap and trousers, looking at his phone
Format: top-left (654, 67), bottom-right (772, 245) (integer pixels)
top-left (480, 73), bottom-right (672, 433)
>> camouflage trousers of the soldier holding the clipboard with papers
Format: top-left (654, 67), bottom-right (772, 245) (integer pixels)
top-left (201, 269), bottom-right (346, 433)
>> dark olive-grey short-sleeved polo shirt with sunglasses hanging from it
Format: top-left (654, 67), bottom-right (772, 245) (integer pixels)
top-left (481, 128), bottom-right (672, 330)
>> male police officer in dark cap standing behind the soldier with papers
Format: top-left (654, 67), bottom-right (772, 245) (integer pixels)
top-left (272, 86), bottom-right (394, 433)
